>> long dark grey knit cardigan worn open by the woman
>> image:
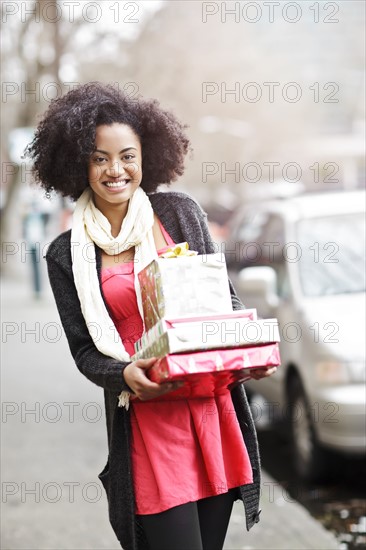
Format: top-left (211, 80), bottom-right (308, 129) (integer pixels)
top-left (46, 192), bottom-right (260, 550)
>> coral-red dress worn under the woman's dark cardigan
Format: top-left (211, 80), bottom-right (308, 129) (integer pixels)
top-left (102, 222), bottom-right (253, 514)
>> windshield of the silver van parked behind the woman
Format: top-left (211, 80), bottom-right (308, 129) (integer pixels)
top-left (297, 213), bottom-right (365, 297)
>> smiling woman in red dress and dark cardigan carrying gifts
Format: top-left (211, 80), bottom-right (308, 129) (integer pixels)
top-left (28, 83), bottom-right (275, 550)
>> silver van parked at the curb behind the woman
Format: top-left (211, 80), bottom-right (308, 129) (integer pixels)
top-left (226, 191), bottom-right (366, 479)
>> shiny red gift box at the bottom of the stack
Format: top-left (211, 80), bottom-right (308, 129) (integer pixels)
top-left (135, 343), bottom-right (281, 401)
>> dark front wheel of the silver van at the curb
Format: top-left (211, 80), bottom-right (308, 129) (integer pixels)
top-left (288, 377), bottom-right (330, 481)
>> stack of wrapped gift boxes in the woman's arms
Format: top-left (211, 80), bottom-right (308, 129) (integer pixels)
top-left (133, 243), bottom-right (280, 400)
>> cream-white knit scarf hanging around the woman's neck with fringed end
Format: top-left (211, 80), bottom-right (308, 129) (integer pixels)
top-left (71, 187), bottom-right (157, 409)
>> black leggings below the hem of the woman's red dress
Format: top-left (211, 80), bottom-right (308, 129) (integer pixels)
top-left (139, 489), bottom-right (236, 550)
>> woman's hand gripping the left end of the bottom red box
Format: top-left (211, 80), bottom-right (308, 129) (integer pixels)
top-left (123, 357), bottom-right (183, 401)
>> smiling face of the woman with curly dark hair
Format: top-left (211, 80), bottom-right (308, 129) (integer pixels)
top-left (88, 123), bottom-right (142, 215)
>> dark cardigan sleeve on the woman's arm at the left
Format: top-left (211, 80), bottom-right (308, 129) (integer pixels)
top-left (46, 251), bottom-right (132, 393)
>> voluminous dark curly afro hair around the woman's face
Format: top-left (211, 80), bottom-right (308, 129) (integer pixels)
top-left (25, 82), bottom-right (190, 200)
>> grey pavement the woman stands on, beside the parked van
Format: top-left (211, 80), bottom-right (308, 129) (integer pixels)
top-left (1, 276), bottom-right (339, 550)
